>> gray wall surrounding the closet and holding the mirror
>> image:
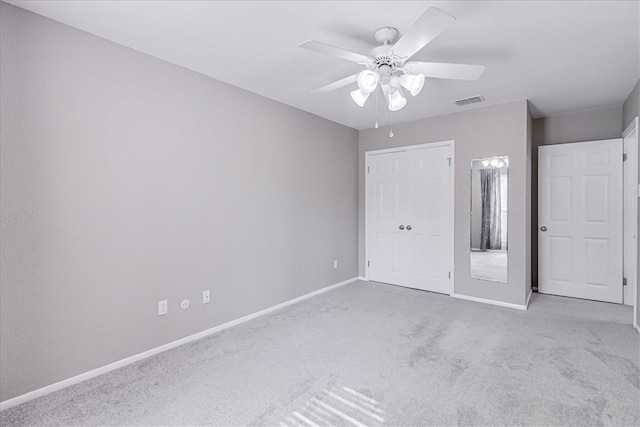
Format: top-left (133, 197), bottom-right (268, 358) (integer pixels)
top-left (358, 101), bottom-right (530, 304)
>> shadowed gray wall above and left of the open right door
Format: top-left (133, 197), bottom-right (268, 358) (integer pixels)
top-left (531, 107), bottom-right (622, 287)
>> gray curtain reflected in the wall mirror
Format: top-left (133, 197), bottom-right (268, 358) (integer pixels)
top-left (480, 169), bottom-right (502, 251)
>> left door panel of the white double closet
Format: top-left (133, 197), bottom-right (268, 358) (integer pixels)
top-left (365, 151), bottom-right (406, 285)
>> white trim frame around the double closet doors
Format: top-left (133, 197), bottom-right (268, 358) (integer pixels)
top-left (363, 139), bottom-right (456, 295)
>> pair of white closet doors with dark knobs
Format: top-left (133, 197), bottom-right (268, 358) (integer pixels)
top-left (365, 146), bottom-right (453, 294)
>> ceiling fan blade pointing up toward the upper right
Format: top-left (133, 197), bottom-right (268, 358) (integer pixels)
top-left (392, 7), bottom-right (456, 58)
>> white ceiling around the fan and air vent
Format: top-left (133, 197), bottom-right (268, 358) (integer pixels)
top-left (9, 0), bottom-right (640, 129)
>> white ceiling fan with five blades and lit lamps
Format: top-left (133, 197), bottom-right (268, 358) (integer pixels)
top-left (299, 7), bottom-right (485, 111)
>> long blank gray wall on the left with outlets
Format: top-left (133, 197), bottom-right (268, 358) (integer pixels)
top-left (0, 3), bottom-right (358, 400)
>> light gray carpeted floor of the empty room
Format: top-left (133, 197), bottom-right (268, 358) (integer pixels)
top-left (0, 282), bottom-right (640, 426)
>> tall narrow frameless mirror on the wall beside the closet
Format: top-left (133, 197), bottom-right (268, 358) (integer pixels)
top-left (470, 156), bottom-right (509, 283)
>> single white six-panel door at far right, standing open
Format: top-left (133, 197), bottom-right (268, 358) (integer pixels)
top-left (538, 139), bottom-right (623, 303)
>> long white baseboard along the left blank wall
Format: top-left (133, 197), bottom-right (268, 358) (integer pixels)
top-left (0, 277), bottom-right (360, 411)
